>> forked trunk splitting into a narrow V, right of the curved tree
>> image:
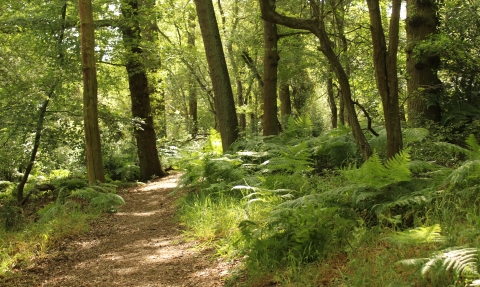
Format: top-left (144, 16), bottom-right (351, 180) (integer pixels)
top-left (367, 0), bottom-right (403, 159)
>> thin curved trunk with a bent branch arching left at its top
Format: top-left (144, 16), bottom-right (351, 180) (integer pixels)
top-left (259, 0), bottom-right (372, 159)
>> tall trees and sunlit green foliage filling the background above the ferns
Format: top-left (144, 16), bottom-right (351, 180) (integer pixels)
top-left (0, 0), bottom-right (480, 190)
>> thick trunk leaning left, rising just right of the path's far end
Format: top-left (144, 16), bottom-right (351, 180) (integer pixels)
top-left (195, 0), bottom-right (238, 152)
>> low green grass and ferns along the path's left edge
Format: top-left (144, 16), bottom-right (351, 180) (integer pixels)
top-left (0, 178), bottom-right (125, 278)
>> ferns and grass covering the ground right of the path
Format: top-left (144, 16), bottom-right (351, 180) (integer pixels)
top-left (175, 121), bottom-right (480, 286)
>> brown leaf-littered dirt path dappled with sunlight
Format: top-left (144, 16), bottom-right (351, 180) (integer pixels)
top-left (0, 174), bottom-right (238, 287)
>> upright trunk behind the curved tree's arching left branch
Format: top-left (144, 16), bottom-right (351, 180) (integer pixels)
top-left (263, 1), bottom-right (279, 136)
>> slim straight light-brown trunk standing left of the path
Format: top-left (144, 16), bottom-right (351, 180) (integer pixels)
top-left (78, 0), bottom-right (105, 184)
